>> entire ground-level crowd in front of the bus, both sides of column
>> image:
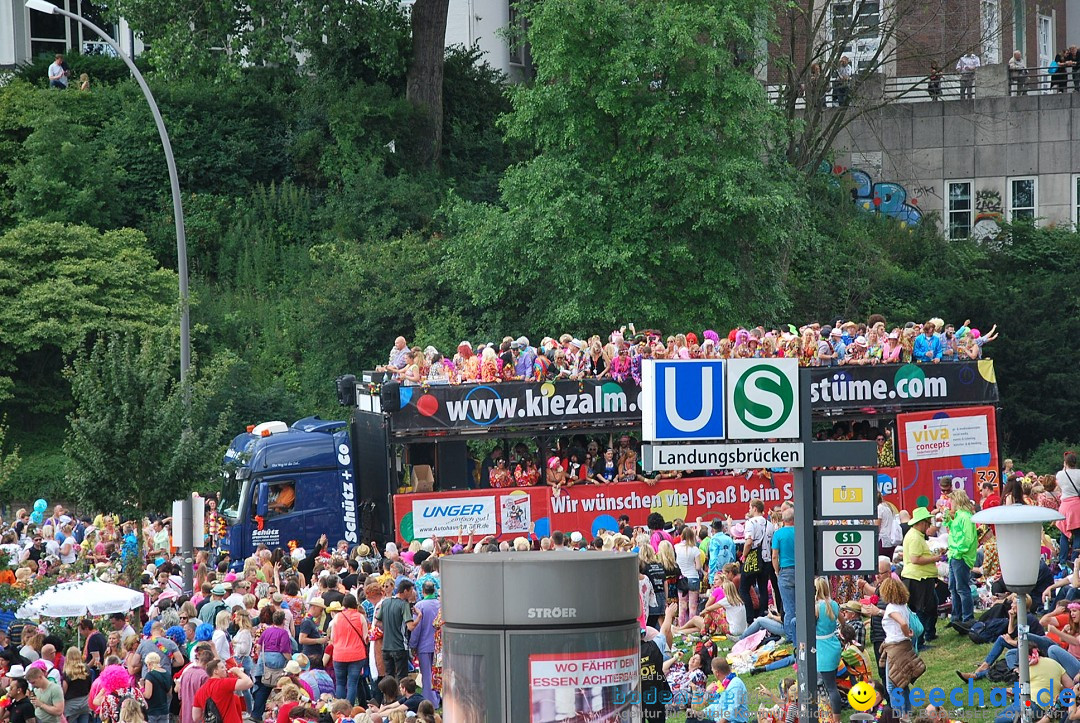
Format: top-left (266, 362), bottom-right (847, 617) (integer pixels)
top-left (0, 452), bottom-right (1080, 723)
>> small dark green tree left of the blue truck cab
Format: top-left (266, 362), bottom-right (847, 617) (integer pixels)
top-left (64, 334), bottom-right (225, 514)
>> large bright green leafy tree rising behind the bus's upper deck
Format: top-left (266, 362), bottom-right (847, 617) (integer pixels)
top-left (443, 0), bottom-right (799, 329)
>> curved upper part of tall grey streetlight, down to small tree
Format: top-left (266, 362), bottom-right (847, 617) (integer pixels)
top-left (26, 0), bottom-right (191, 386)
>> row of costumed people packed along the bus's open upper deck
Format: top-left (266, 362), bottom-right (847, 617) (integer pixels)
top-left (377, 314), bottom-right (998, 385)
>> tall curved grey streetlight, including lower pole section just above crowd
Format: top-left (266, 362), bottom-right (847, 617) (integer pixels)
top-left (26, 0), bottom-right (194, 591)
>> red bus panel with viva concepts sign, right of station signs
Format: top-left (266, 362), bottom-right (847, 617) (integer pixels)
top-left (882, 406), bottom-right (1001, 510)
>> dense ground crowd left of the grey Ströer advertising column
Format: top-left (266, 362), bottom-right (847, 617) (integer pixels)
top-left (0, 516), bottom-right (450, 723)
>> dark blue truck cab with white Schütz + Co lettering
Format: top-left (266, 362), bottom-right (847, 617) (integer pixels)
top-left (218, 417), bottom-right (361, 562)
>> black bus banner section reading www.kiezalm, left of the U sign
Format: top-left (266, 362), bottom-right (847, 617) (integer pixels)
top-left (391, 379), bottom-right (642, 431)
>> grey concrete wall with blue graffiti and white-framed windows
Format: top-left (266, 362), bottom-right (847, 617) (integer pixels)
top-left (829, 65), bottom-right (1080, 238)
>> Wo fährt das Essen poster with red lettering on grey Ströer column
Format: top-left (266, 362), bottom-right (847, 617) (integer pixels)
top-left (529, 650), bottom-right (640, 723)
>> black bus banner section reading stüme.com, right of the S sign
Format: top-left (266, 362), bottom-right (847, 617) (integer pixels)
top-left (804, 359), bottom-right (998, 412)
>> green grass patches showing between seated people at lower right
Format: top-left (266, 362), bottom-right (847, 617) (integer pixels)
top-left (667, 618), bottom-right (1019, 723)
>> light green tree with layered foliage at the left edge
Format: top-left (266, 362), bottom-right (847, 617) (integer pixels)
top-left (0, 222), bottom-right (177, 414)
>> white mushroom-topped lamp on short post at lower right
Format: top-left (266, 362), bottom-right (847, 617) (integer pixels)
top-left (972, 505), bottom-right (1065, 722)
